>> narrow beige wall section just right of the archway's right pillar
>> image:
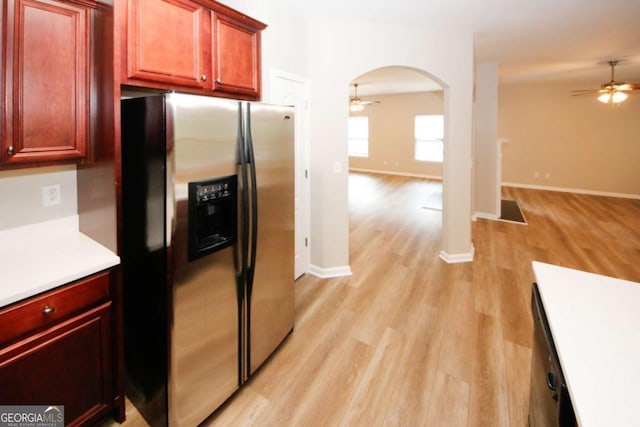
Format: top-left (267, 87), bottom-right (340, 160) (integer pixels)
top-left (473, 63), bottom-right (500, 218)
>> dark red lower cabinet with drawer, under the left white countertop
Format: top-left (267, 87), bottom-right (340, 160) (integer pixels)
top-left (0, 275), bottom-right (122, 425)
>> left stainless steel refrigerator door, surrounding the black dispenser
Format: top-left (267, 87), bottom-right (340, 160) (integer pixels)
top-left (167, 94), bottom-right (240, 426)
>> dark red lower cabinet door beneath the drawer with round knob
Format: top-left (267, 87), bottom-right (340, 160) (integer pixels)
top-left (0, 303), bottom-right (112, 425)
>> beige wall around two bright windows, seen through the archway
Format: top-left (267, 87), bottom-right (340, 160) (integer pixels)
top-left (349, 91), bottom-right (444, 179)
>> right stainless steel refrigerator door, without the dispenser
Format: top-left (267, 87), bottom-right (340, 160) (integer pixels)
top-left (248, 104), bottom-right (295, 374)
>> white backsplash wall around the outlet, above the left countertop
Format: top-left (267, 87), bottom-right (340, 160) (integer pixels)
top-left (0, 165), bottom-right (78, 230)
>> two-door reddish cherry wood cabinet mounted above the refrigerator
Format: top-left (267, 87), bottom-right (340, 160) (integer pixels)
top-left (119, 0), bottom-right (266, 100)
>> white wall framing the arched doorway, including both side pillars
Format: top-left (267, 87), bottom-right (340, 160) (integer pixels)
top-left (309, 20), bottom-right (473, 268)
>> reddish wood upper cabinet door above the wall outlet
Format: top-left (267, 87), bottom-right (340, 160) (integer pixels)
top-left (0, 0), bottom-right (91, 163)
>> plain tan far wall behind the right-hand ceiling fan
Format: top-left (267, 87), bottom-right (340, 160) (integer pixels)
top-left (498, 83), bottom-right (640, 197)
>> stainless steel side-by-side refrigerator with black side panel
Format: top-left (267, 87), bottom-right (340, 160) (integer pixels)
top-left (121, 93), bottom-right (294, 426)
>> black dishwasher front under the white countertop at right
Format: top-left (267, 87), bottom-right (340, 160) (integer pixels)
top-left (529, 283), bottom-right (577, 427)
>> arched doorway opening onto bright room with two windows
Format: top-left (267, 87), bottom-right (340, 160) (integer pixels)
top-left (348, 66), bottom-right (446, 271)
